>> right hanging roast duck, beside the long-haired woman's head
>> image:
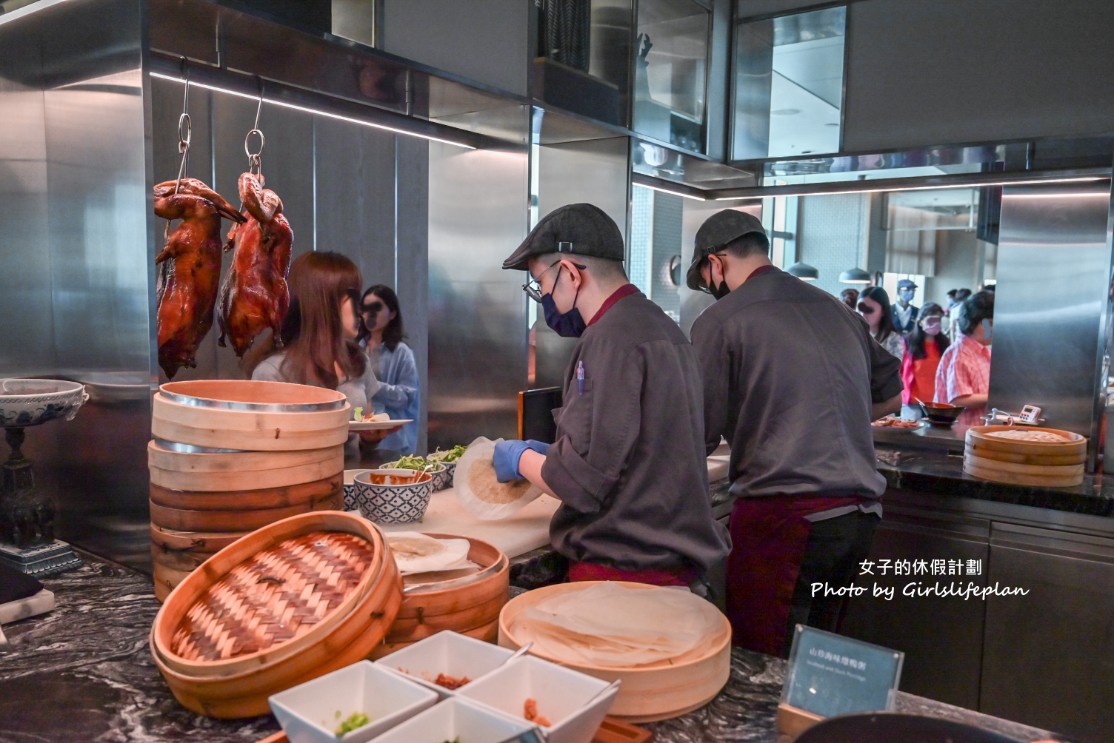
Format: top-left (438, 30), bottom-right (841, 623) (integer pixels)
top-left (217, 172), bottom-right (294, 356)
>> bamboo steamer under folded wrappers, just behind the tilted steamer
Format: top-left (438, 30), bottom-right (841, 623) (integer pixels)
top-left (372, 534), bottom-right (510, 658)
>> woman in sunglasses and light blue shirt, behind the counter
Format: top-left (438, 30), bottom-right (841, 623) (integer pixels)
top-left (359, 284), bottom-right (421, 456)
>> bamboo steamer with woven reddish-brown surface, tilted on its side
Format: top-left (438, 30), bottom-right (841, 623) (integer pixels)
top-left (150, 511), bottom-right (402, 717)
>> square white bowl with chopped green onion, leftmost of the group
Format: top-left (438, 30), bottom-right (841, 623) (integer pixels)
top-left (267, 661), bottom-right (438, 743)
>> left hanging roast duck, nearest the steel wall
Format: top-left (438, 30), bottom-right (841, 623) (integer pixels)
top-left (155, 178), bottom-right (245, 379)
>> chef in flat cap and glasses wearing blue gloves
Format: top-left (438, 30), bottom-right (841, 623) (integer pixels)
top-left (494, 204), bottom-right (727, 586)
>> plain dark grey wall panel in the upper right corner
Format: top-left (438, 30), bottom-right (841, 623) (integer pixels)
top-left (842, 0), bottom-right (1114, 151)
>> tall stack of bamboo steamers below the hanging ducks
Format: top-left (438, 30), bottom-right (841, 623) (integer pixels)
top-left (147, 380), bottom-right (350, 600)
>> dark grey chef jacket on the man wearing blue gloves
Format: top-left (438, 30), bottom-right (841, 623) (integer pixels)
top-left (541, 291), bottom-right (729, 570)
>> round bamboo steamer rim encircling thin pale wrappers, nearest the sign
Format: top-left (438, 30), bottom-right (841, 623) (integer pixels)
top-left (499, 580), bottom-right (731, 723)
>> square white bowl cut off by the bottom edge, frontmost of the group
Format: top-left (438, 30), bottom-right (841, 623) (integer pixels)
top-left (369, 699), bottom-right (536, 743)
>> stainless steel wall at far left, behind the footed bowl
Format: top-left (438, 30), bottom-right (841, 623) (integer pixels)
top-left (0, 0), bottom-right (153, 563)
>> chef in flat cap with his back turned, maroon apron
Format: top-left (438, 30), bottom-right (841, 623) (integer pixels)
top-left (687, 209), bottom-right (901, 655)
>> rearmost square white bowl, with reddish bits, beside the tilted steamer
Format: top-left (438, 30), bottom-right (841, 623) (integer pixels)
top-left (375, 629), bottom-right (515, 695)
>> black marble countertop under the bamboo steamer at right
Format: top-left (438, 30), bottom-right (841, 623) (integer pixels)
top-left (874, 443), bottom-right (1114, 518)
